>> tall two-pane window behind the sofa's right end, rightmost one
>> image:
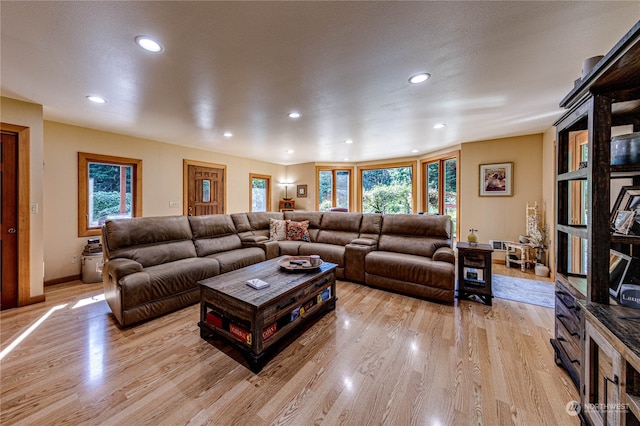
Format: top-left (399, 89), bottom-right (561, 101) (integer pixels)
top-left (421, 151), bottom-right (459, 237)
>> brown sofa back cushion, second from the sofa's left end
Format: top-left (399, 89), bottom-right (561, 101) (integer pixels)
top-left (189, 214), bottom-right (242, 257)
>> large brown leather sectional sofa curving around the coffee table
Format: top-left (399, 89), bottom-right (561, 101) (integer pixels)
top-left (102, 211), bottom-right (455, 326)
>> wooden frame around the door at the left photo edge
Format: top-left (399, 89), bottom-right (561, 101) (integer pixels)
top-left (0, 122), bottom-right (30, 306)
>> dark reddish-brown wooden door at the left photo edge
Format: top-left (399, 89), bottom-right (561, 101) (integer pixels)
top-left (0, 131), bottom-right (18, 309)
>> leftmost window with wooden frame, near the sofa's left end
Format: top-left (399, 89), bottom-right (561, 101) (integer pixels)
top-left (78, 152), bottom-right (142, 237)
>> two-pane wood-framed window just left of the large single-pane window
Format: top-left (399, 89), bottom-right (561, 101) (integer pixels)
top-left (316, 167), bottom-right (353, 211)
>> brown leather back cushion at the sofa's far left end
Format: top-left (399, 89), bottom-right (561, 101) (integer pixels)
top-left (102, 216), bottom-right (196, 267)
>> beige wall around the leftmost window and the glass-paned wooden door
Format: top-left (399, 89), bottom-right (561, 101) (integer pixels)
top-left (43, 121), bottom-right (287, 281)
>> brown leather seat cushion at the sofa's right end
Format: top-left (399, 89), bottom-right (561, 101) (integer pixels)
top-left (365, 251), bottom-right (455, 290)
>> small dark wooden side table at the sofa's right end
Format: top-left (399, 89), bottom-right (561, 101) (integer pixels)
top-left (457, 242), bottom-right (493, 306)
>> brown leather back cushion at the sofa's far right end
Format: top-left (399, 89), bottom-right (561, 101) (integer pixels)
top-left (378, 214), bottom-right (451, 257)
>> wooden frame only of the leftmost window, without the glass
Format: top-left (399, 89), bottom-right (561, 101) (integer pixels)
top-left (78, 152), bottom-right (142, 237)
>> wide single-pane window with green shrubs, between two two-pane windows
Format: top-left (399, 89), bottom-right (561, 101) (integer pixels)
top-left (358, 162), bottom-right (415, 214)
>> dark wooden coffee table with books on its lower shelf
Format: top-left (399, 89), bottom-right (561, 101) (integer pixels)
top-left (198, 256), bottom-right (337, 372)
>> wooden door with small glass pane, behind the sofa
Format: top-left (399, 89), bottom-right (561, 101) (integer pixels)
top-left (187, 164), bottom-right (225, 216)
